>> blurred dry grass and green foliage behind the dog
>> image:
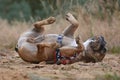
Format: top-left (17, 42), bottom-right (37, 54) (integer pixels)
top-left (0, 0), bottom-right (120, 53)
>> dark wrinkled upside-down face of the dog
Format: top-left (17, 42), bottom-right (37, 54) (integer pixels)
top-left (90, 36), bottom-right (106, 53)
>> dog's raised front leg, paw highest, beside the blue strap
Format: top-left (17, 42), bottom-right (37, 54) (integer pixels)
top-left (62, 13), bottom-right (79, 38)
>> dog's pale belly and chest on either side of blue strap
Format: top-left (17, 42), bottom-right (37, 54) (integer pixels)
top-left (43, 34), bottom-right (77, 47)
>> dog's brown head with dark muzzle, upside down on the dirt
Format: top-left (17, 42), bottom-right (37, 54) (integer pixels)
top-left (82, 36), bottom-right (107, 62)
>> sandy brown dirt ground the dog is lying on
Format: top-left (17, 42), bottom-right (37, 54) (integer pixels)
top-left (0, 50), bottom-right (120, 80)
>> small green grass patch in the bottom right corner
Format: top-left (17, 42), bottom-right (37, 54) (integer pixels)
top-left (95, 73), bottom-right (120, 80)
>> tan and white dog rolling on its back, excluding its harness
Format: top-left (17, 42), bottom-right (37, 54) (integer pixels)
top-left (16, 13), bottom-right (106, 63)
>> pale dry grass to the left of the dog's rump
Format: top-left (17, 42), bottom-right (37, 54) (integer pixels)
top-left (0, 19), bottom-right (29, 50)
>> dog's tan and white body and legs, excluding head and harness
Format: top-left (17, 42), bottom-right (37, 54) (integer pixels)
top-left (18, 13), bottom-right (84, 63)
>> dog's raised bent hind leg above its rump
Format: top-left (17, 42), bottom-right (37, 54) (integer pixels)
top-left (27, 17), bottom-right (55, 43)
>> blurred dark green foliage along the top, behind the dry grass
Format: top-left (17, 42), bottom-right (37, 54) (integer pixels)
top-left (0, 0), bottom-right (120, 21)
